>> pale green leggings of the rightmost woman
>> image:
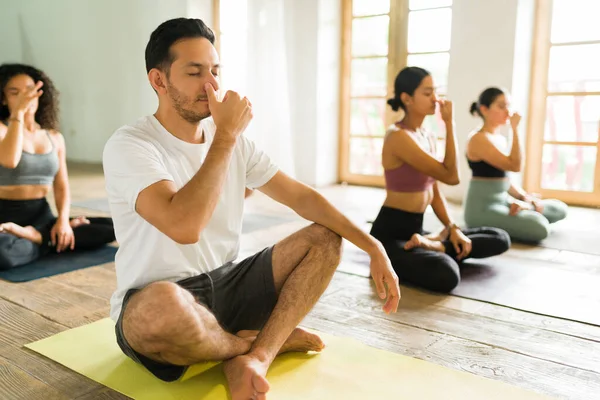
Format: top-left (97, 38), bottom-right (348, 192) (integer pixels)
top-left (465, 179), bottom-right (567, 242)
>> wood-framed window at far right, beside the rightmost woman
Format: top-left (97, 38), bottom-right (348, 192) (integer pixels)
top-left (525, 0), bottom-right (600, 206)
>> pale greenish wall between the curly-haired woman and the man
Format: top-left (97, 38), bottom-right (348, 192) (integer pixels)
top-left (0, 0), bottom-right (212, 163)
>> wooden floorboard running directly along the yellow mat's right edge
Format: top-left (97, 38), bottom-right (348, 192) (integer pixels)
top-left (302, 303), bottom-right (600, 400)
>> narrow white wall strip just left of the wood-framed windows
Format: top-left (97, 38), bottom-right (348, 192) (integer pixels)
top-left (284, 0), bottom-right (341, 186)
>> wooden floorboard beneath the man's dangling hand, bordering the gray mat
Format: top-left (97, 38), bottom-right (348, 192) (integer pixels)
top-left (323, 274), bottom-right (600, 373)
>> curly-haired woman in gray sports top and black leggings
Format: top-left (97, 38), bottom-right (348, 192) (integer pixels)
top-left (0, 64), bottom-right (115, 269)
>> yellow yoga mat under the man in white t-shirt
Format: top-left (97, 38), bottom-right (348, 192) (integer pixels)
top-left (26, 319), bottom-right (548, 400)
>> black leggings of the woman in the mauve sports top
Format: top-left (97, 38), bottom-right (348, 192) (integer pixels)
top-left (371, 206), bottom-right (510, 293)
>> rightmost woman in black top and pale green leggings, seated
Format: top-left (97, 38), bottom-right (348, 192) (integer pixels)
top-left (465, 88), bottom-right (567, 242)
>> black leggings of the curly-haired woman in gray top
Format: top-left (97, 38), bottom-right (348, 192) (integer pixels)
top-left (0, 199), bottom-right (115, 269)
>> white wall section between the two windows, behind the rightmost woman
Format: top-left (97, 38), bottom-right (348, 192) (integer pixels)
top-left (444, 0), bottom-right (534, 202)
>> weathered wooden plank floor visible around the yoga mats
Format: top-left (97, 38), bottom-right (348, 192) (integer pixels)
top-left (0, 166), bottom-right (600, 400)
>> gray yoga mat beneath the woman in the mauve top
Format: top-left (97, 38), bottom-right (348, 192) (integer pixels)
top-left (338, 249), bottom-right (600, 326)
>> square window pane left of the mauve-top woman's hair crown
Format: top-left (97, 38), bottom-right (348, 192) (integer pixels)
top-left (351, 57), bottom-right (387, 96)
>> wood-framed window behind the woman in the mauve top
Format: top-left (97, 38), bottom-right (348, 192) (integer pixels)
top-left (340, 0), bottom-right (452, 186)
